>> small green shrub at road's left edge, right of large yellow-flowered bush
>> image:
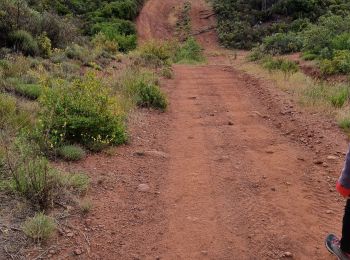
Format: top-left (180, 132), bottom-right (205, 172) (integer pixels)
top-left (137, 83), bottom-right (168, 111)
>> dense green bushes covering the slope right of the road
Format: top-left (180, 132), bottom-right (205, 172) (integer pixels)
top-left (214, 0), bottom-right (350, 75)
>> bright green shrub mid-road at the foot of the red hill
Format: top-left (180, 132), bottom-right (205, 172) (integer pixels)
top-left (174, 37), bottom-right (205, 63)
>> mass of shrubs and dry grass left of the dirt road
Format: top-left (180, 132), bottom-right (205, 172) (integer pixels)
top-left (0, 0), bottom-right (204, 254)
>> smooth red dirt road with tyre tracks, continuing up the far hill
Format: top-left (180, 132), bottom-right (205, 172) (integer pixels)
top-left (138, 0), bottom-right (346, 259)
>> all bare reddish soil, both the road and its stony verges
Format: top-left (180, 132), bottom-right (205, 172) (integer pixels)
top-left (25, 0), bottom-right (346, 260)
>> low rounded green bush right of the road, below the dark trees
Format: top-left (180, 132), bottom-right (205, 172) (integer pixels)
top-left (263, 32), bottom-right (303, 55)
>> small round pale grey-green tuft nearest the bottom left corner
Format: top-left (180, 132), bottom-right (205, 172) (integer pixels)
top-left (22, 212), bottom-right (56, 242)
